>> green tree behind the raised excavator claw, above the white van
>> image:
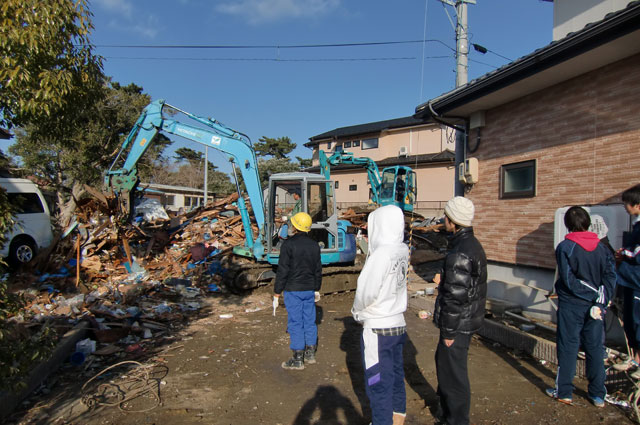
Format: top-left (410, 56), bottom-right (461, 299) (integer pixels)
top-left (9, 83), bottom-right (171, 225)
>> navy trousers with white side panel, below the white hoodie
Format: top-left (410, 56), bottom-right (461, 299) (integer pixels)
top-left (360, 328), bottom-right (407, 425)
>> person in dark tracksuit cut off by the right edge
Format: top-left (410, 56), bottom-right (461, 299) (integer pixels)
top-left (616, 184), bottom-right (640, 372)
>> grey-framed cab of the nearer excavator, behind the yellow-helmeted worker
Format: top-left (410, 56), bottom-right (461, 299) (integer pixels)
top-left (265, 172), bottom-right (356, 264)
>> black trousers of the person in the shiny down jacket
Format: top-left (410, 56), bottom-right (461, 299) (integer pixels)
top-left (436, 334), bottom-right (471, 425)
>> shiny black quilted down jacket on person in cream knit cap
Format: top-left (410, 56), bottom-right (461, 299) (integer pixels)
top-left (433, 227), bottom-right (487, 339)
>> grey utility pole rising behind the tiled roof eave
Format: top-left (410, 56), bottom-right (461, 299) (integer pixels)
top-left (440, 0), bottom-right (476, 196)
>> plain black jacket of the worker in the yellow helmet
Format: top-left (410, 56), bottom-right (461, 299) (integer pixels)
top-left (274, 232), bottom-right (322, 294)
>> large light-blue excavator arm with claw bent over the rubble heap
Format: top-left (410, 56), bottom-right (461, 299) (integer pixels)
top-left (105, 100), bottom-right (265, 260)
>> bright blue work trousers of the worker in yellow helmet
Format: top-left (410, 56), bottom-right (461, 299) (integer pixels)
top-left (284, 291), bottom-right (318, 350)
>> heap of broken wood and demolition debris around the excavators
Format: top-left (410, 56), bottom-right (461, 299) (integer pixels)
top-left (2, 188), bottom-right (446, 410)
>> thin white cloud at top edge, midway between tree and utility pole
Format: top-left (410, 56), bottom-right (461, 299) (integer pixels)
top-left (216, 0), bottom-right (341, 24)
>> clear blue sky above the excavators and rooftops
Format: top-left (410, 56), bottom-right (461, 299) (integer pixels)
top-left (53, 0), bottom-right (553, 170)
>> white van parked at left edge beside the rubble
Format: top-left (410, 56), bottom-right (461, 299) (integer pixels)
top-left (0, 178), bottom-right (53, 265)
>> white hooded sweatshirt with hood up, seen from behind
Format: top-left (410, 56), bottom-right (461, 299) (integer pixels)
top-left (351, 205), bottom-right (409, 329)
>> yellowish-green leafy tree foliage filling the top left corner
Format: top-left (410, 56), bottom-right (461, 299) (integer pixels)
top-left (0, 0), bottom-right (103, 128)
